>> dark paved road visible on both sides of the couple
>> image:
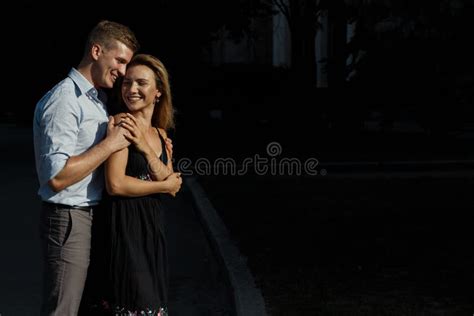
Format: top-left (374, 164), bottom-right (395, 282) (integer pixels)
top-left (0, 126), bottom-right (233, 316)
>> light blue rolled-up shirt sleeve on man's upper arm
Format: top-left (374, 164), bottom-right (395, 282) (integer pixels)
top-left (40, 89), bottom-right (81, 182)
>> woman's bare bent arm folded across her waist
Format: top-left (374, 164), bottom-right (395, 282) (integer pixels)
top-left (105, 148), bottom-right (182, 197)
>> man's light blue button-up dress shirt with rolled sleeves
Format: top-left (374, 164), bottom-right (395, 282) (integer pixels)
top-left (33, 68), bottom-right (108, 206)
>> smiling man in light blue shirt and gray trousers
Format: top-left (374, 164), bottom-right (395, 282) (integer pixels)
top-left (33, 21), bottom-right (139, 316)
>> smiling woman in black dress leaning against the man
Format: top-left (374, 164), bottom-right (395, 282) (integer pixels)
top-left (105, 54), bottom-right (182, 316)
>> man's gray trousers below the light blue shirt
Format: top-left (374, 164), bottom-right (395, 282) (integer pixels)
top-left (41, 203), bottom-right (92, 316)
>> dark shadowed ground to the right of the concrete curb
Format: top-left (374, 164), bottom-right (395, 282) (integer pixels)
top-left (200, 174), bottom-right (474, 315)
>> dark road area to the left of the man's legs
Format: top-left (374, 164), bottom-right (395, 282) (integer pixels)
top-left (0, 127), bottom-right (42, 316)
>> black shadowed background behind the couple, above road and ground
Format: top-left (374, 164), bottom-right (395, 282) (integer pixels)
top-left (0, 0), bottom-right (474, 165)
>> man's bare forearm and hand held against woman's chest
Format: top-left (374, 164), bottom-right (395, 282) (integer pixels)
top-left (48, 117), bottom-right (130, 192)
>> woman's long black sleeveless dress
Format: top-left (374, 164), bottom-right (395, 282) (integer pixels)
top-left (107, 133), bottom-right (168, 315)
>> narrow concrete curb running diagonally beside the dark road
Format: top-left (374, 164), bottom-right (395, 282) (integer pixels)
top-left (184, 177), bottom-right (267, 316)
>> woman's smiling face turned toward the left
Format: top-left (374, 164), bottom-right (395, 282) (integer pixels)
top-left (122, 65), bottom-right (161, 112)
